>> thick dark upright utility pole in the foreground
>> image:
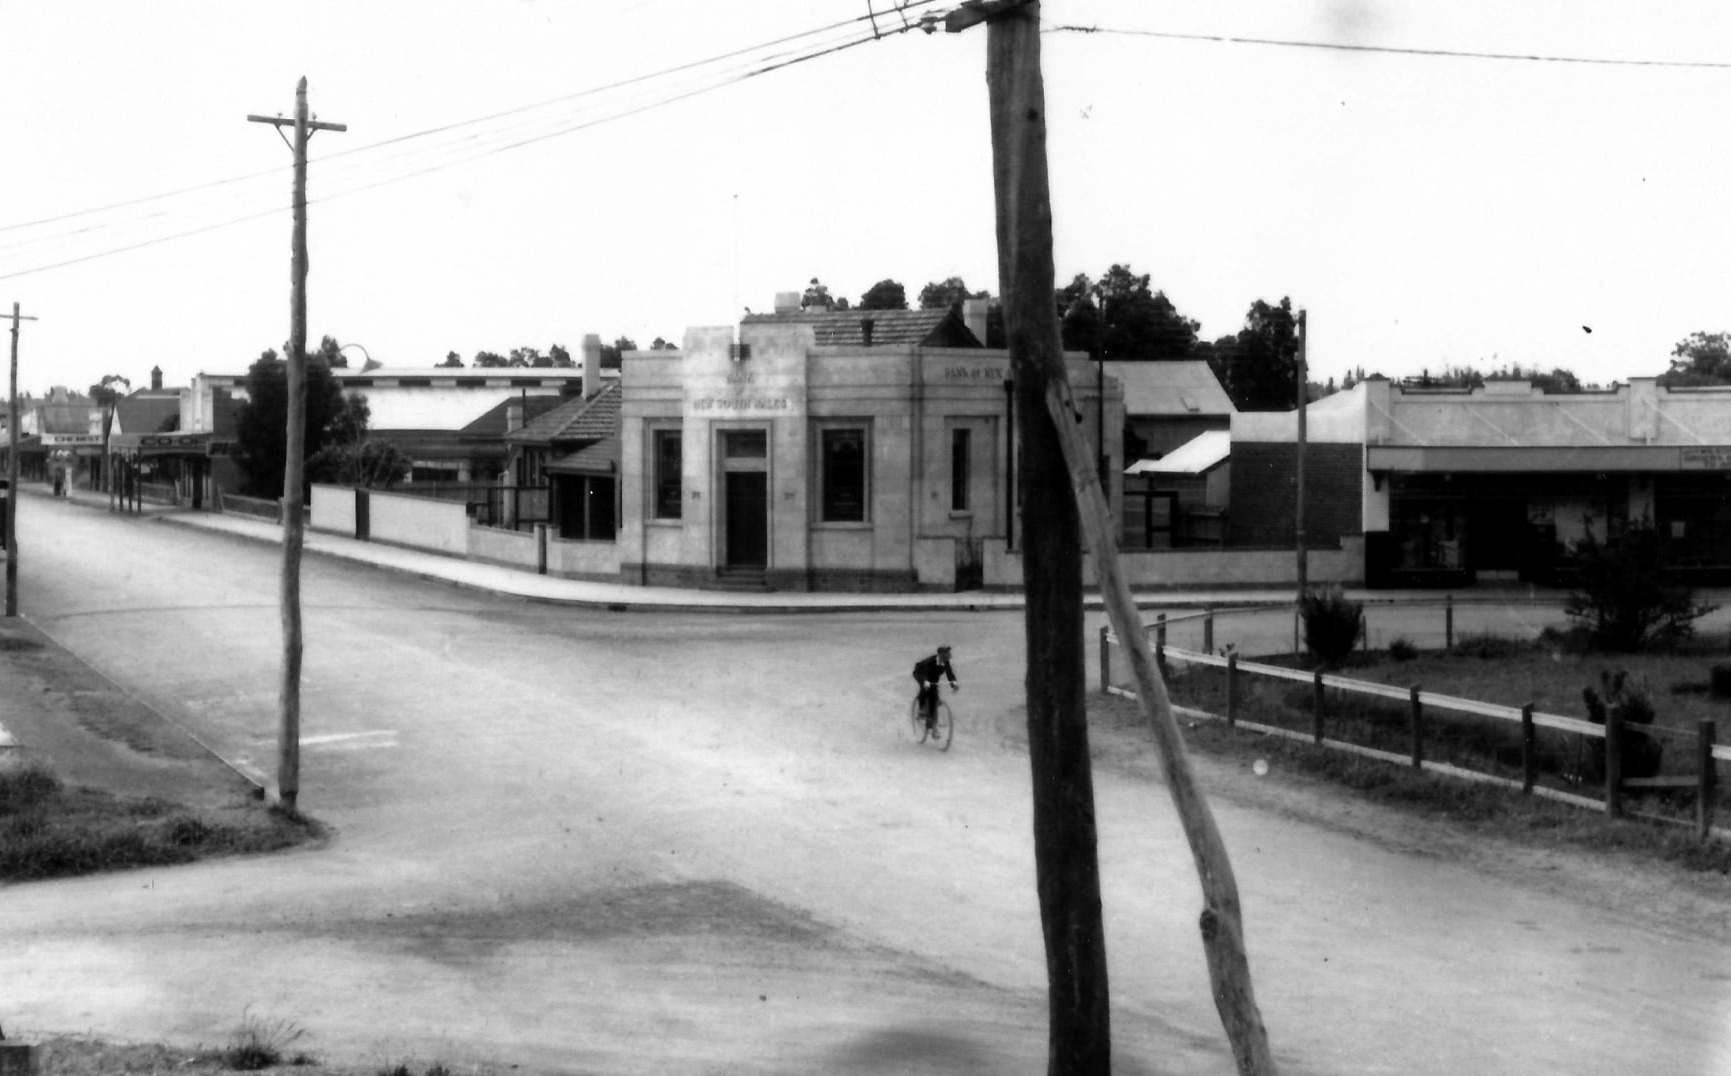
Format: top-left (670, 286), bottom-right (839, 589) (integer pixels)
top-left (945, 0), bottom-right (1111, 1076)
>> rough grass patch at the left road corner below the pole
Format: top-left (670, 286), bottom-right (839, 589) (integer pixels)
top-left (0, 761), bottom-right (324, 882)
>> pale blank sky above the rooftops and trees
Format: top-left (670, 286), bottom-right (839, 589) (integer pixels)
top-left (0, 0), bottom-right (1731, 393)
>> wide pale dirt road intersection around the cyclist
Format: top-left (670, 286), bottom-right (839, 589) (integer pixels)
top-left (0, 509), bottom-right (1731, 1074)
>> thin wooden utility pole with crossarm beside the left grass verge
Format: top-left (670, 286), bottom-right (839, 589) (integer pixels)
top-left (246, 76), bottom-right (348, 811)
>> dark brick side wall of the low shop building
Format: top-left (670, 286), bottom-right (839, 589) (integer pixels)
top-left (1227, 441), bottom-right (1364, 547)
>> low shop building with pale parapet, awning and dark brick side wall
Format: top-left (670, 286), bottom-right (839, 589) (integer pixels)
top-left (1231, 377), bottom-right (1731, 586)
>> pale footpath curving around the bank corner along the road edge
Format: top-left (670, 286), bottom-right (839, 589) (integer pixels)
top-left (21, 483), bottom-right (1561, 614)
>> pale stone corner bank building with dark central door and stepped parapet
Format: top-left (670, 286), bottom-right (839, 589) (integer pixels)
top-left (616, 292), bottom-right (1123, 592)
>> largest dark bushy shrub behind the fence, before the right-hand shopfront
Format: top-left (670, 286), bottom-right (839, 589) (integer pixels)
top-left (1563, 521), bottom-right (1717, 652)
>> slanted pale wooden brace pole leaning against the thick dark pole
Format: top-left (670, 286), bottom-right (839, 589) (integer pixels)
top-left (1046, 381), bottom-right (1274, 1076)
